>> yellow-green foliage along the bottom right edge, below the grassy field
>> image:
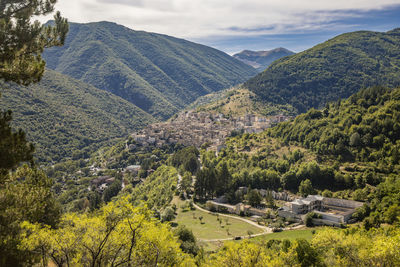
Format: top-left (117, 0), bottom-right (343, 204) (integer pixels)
top-left (204, 228), bottom-right (400, 267)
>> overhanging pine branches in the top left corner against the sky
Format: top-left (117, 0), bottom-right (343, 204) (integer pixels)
top-left (0, 0), bottom-right (68, 85)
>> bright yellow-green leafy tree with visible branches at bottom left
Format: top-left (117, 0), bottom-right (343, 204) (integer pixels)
top-left (21, 198), bottom-right (192, 267)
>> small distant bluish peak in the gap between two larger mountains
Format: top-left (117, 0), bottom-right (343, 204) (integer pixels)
top-left (233, 47), bottom-right (294, 71)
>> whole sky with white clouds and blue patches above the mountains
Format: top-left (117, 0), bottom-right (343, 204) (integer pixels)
top-left (41, 0), bottom-right (400, 54)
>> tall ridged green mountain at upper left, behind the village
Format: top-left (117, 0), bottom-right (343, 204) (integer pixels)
top-left (43, 22), bottom-right (257, 119)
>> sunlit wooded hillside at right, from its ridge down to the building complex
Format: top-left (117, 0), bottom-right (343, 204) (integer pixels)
top-left (195, 87), bottom-right (400, 227)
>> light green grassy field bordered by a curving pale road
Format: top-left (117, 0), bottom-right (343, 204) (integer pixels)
top-left (173, 198), bottom-right (262, 239)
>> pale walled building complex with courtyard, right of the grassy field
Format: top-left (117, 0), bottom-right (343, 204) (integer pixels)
top-left (278, 195), bottom-right (364, 226)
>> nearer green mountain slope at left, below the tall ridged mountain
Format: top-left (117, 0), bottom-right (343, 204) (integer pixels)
top-left (0, 70), bottom-right (155, 162)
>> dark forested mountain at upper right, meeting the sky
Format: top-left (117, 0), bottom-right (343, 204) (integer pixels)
top-left (244, 28), bottom-right (400, 112)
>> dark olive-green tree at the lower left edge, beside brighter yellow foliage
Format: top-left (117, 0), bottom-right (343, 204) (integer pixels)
top-left (0, 165), bottom-right (60, 266)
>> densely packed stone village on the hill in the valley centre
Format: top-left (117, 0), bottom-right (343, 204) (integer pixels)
top-left (129, 111), bottom-right (291, 150)
